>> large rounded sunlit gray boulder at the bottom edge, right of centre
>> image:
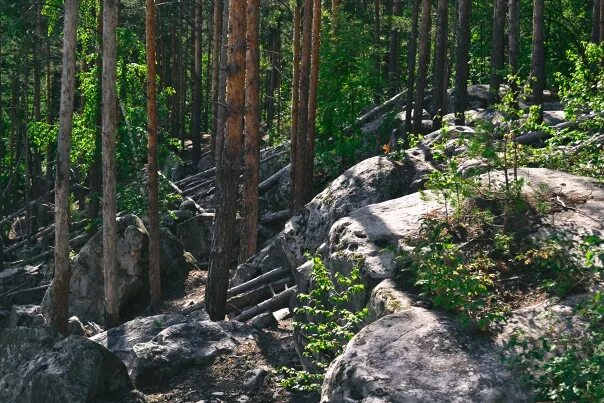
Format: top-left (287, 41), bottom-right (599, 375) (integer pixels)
top-left (321, 308), bottom-right (531, 403)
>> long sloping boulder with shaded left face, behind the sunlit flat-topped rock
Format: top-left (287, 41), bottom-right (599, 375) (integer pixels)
top-left (232, 155), bottom-right (434, 285)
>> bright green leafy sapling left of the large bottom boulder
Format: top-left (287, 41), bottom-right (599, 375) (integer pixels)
top-left (282, 256), bottom-right (368, 392)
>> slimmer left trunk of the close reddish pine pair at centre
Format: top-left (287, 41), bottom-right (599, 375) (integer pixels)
top-left (290, 0), bottom-right (302, 213)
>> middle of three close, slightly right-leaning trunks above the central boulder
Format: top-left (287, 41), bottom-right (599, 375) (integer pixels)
top-left (413, 0), bottom-right (432, 133)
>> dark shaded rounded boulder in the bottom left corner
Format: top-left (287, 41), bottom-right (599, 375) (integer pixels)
top-left (0, 327), bottom-right (144, 403)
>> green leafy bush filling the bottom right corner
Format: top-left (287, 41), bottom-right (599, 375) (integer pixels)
top-left (509, 292), bottom-right (604, 402)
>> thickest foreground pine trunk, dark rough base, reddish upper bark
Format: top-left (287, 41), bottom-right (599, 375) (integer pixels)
top-left (205, 0), bottom-right (247, 321)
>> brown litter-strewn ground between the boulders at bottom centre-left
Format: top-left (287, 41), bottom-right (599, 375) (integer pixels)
top-left (141, 270), bottom-right (308, 403)
